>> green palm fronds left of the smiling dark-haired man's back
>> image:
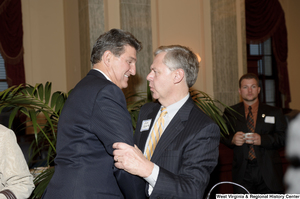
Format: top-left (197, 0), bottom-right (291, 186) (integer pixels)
top-left (0, 82), bottom-right (68, 163)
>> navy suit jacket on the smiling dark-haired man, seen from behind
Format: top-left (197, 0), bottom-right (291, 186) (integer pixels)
top-left (44, 70), bottom-right (145, 199)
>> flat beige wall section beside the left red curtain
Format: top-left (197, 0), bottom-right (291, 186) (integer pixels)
top-left (22, 0), bottom-right (67, 91)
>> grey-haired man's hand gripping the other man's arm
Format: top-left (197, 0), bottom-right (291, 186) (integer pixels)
top-left (113, 142), bottom-right (154, 178)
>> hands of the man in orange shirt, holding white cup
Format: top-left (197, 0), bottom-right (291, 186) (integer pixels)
top-left (232, 131), bottom-right (261, 146)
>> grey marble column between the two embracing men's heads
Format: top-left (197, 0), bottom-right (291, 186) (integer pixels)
top-left (120, 0), bottom-right (153, 93)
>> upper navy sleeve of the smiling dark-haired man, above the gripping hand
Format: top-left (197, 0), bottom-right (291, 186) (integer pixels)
top-left (91, 85), bottom-right (133, 155)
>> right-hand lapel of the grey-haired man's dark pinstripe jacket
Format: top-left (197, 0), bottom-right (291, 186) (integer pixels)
top-left (151, 98), bottom-right (194, 162)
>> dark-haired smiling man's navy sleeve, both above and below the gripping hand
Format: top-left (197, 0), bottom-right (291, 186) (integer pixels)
top-left (92, 85), bottom-right (145, 199)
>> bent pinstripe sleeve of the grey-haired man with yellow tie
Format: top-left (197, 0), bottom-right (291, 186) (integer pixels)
top-left (151, 123), bottom-right (220, 199)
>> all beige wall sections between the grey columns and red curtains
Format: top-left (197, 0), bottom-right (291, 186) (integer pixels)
top-left (22, 0), bottom-right (300, 110)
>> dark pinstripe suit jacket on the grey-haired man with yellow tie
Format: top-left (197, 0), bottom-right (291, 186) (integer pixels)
top-left (134, 98), bottom-right (220, 199)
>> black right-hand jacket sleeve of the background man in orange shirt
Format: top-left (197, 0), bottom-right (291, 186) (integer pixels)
top-left (260, 108), bottom-right (287, 149)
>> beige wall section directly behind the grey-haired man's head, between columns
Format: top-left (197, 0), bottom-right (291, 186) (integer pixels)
top-left (151, 0), bottom-right (213, 95)
